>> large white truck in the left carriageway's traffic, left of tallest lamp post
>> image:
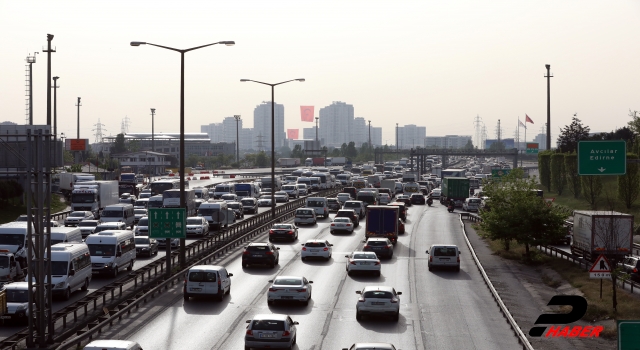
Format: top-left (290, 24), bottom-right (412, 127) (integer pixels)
top-left (71, 180), bottom-right (119, 218)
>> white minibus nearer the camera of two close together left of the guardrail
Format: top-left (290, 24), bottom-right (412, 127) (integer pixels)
top-left (51, 242), bottom-right (93, 300)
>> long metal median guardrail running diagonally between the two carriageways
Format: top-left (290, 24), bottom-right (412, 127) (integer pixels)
top-left (0, 189), bottom-right (340, 349)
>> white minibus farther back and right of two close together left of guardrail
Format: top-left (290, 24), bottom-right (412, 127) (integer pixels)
top-left (85, 230), bottom-right (136, 278)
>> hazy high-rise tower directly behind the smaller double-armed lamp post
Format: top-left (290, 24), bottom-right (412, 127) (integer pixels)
top-left (253, 101), bottom-right (286, 151)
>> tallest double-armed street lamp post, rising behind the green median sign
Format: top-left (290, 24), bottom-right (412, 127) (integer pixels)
top-left (131, 41), bottom-right (236, 270)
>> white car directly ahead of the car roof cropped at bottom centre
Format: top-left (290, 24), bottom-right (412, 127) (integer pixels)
top-left (356, 286), bottom-right (402, 322)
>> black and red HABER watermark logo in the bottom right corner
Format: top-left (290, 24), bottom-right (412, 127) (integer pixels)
top-left (529, 295), bottom-right (604, 338)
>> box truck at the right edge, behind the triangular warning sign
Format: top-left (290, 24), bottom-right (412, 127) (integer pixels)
top-left (571, 210), bottom-right (633, 261)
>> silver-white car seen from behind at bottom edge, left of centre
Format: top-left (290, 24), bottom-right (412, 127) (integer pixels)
top-left (244, 314), bottom-right (298, 350)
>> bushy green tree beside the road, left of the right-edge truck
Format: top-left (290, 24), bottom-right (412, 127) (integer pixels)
top-left (480, 169), bottom-right (566, 259)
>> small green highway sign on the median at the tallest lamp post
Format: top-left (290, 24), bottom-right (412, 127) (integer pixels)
top-left (149, 208), bottom-right (187, 238)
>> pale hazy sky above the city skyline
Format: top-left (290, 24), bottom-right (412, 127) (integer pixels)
top-left (0, 0), bottom-right (640, 144)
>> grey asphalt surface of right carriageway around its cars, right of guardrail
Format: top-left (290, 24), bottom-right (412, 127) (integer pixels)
top-left (95, 198), bottom-right (519, 349)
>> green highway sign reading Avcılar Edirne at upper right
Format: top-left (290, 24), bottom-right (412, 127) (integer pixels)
top-left (578, 140), bottom-right (627, 175)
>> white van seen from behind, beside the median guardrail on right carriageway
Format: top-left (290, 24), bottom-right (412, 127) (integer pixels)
top-left (183, 265), bottom-right (233, 301)
